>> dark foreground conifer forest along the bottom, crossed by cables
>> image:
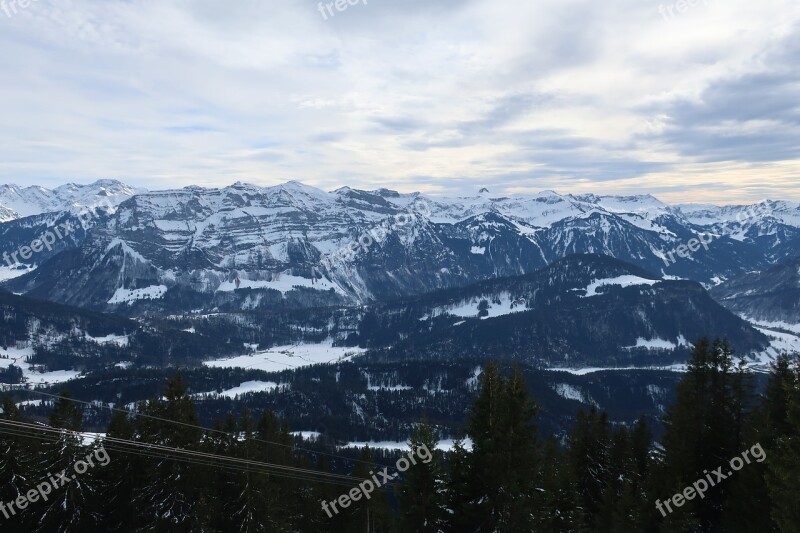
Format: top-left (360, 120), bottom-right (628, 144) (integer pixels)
top-left (0, 339), bottom-right (800, 533)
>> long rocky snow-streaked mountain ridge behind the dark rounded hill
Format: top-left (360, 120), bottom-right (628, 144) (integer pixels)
top-left (0, 181), bottom-right (800, 314)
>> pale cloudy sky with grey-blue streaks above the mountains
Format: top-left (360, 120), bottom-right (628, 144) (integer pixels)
top-left (0, 0), bottom-right (800, 204)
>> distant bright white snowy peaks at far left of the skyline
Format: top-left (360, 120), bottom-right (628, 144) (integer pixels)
top-left (0, 180), bottom-right (144, 222)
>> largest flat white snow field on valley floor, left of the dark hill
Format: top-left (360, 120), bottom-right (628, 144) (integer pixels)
top-left (203, 340), bottom-right (364, 372)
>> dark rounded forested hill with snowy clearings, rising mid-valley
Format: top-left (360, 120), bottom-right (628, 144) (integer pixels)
top-left (354, 255), bottom-right (768, 367)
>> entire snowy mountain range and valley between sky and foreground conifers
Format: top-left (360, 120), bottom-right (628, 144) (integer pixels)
top-left (0, 181), bottom-right (800, 448)
